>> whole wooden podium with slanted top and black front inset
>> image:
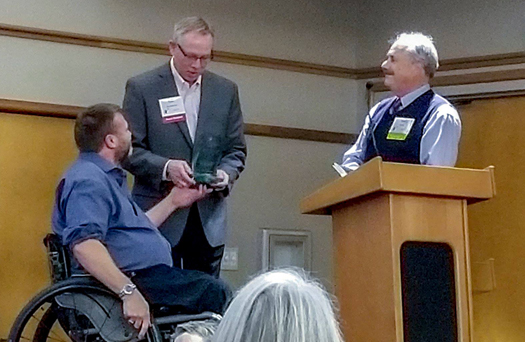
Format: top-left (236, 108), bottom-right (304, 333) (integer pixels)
top-left (301, 158), bottom-right (495, 342)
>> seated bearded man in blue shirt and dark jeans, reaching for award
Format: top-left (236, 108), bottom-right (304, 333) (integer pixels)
top-left (49, 104), bottom-right (231, 338)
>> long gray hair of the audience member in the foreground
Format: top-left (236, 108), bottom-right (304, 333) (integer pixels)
top-left (212, 269), bottom-right (343, 342)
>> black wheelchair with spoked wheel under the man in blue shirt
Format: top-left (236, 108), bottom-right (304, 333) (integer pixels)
top-left (9, 234), bottom-right (221, 342)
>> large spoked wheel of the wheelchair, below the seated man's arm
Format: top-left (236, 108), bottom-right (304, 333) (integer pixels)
top-left (9, 279), bottom-right (161, 342)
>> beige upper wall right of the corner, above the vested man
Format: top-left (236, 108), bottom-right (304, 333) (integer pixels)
top-left (357, 0), bottom-right (525, 67)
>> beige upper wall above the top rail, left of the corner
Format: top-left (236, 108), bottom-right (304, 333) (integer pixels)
top-left (0, 0), bottom-right (357, 67)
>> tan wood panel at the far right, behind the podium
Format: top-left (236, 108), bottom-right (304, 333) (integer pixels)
top-left (458, 97), bottom-right (525, 342)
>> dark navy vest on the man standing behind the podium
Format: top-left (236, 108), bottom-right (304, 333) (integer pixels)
top-left (364, 90), bottom-right (446, 164)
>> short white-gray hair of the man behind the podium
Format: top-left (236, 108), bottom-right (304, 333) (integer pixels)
top-left (390, 32), bottom-right (439, 78)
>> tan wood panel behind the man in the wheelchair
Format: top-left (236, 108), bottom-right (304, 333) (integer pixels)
top-left (0, 113), bottom-right (77, 338)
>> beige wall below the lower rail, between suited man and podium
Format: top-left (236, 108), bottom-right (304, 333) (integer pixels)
top-left (223, 137), bottom-right (341, 289)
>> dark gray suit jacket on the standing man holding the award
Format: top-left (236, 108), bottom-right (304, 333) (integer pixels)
top-left (123, 63), bottom-right (246, 247)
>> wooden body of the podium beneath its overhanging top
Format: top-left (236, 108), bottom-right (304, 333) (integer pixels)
top-left (332, 193), bottom-right (472, 342)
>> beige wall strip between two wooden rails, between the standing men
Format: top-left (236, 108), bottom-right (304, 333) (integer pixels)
top-left (211, 63), bottom-right (360, 132)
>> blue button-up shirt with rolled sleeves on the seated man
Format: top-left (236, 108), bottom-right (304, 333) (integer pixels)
top-left (53, 152), bottom-right (172, 271)
